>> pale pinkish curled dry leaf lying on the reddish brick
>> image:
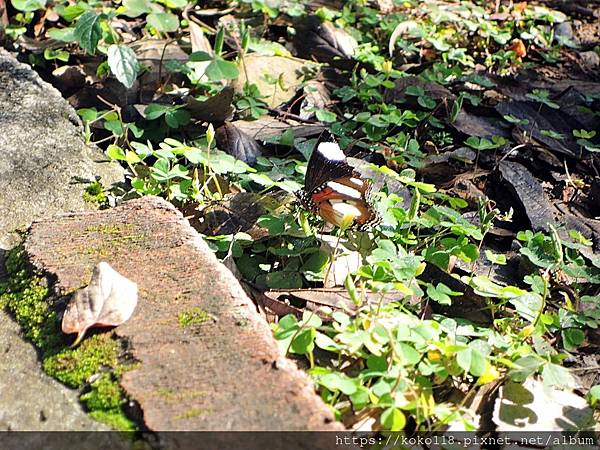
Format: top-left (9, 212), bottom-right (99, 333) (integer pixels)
top-left (62, 262), bottom-right (138, 346)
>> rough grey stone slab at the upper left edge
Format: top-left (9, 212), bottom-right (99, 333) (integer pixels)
top-left (0, 48), bottom-right (124, 249)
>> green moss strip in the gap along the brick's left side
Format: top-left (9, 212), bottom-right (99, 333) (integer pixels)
top-left (0, 246), bottom-right (135, 431)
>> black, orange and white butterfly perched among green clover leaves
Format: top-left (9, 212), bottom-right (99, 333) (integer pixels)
top-left (296, 137), bottom-right (379, 230)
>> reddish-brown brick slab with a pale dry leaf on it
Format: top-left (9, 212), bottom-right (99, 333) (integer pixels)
top-left (25, 197), bottom-right (343, 432)
